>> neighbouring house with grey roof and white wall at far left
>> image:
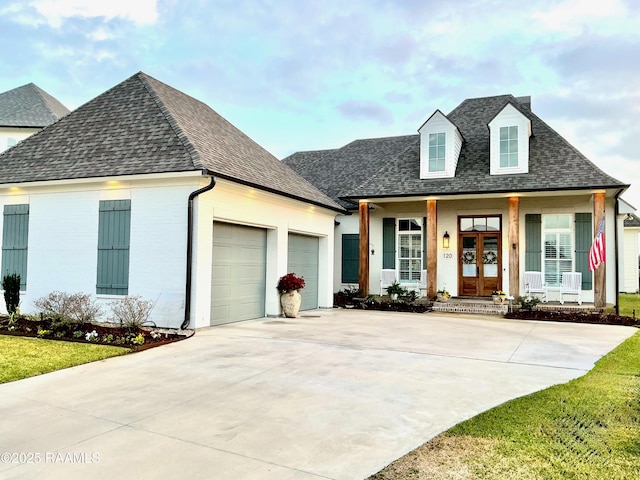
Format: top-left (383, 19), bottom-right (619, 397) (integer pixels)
top-left (0, 83), bottom-right (69, 152)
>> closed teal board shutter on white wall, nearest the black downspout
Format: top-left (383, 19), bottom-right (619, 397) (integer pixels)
top-left (96, 200), bottom-right (131, 295)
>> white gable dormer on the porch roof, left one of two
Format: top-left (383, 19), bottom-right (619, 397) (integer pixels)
top-left (418, 110), bottom-right (462, 179)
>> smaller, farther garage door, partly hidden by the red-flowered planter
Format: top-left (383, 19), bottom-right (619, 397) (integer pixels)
top-left (287, 233), bottom-right (319, 310)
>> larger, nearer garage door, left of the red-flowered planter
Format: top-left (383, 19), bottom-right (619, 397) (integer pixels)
top-left (211, 222), bottom-right (267, 325)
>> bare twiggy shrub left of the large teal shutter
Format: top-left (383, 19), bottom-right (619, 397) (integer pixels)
top-left (33, 291), bottom-right (102, 328)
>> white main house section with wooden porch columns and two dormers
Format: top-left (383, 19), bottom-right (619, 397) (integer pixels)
top-left (284, 95), bottom-right (628, 306)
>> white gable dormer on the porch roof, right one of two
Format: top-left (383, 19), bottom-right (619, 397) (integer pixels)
top-left (489, 103), bottom-right (531, 175)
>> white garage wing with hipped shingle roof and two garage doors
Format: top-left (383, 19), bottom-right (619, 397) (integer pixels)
top-left (0, 72), bottom-right (345, 327)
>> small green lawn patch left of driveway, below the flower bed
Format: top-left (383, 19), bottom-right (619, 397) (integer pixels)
top-left (0, 335), bottom-right (131, 383)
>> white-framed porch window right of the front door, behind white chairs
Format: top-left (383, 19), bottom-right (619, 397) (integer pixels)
top-left (543, 215), bottom-right (573, 287)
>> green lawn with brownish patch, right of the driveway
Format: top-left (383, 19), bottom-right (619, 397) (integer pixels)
top-left (371, 332), bottom-right (640, 480)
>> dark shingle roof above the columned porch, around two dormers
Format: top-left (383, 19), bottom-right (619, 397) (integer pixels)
top-left (283, 95), bottom-right (628, 206)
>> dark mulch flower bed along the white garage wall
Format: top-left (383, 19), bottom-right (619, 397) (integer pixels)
top-left (0, 316), bottom-right (194, 352)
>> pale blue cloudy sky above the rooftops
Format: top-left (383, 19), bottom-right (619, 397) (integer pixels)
top-left (0, 0), bottom-right (640, 210)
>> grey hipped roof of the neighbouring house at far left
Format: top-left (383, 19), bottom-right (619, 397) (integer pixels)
top-left (0, 83), bottom-right (69, 128)
